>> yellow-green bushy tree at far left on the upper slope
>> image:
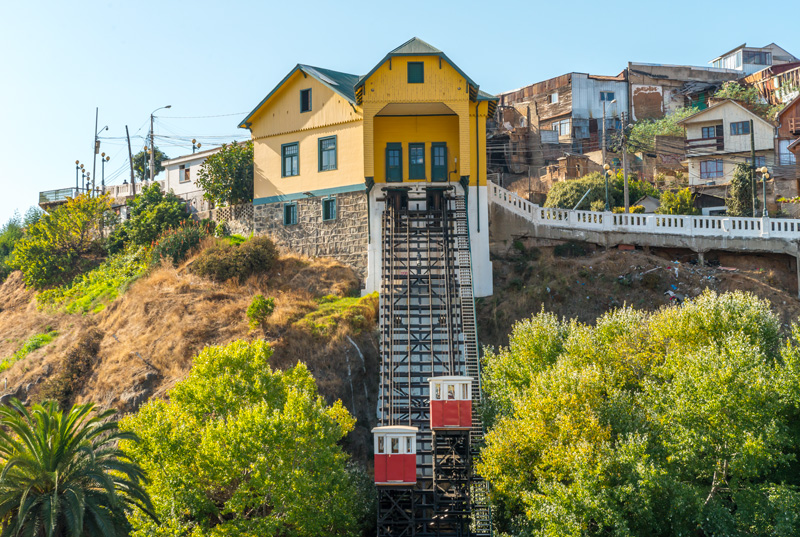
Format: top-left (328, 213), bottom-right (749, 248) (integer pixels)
top-left (11, 195), bottom-right (111, 289)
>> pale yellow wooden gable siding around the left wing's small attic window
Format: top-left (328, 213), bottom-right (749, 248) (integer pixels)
top-left (250, 71), bottom-right (361, 140)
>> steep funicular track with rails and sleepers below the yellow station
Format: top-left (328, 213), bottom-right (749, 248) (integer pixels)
top-left (378, 187), bottom-right (491, 536)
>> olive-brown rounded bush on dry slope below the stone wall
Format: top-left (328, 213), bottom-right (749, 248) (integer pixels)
top-left (192, 236), bottom-right (278, 281)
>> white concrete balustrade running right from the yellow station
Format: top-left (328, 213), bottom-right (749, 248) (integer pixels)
top-left (488, 181), bottom-right (800, 240)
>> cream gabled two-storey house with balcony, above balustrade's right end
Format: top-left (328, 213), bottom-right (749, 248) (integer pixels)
top-left (678, 99), bottom-right (775, 186)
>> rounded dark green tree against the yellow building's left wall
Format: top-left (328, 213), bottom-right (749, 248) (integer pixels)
top-left (197, 142), bottom-right (253, 205)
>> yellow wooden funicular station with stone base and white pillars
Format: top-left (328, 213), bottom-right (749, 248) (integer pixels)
top-left (240, 38), bottom-right (497, 296)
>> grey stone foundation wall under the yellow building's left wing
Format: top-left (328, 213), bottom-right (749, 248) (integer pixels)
top-left (253, 192), bottom-right (369, 278)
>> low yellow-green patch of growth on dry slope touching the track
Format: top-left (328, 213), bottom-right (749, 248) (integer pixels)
top-left (295, 293), bottom-right (378, 336)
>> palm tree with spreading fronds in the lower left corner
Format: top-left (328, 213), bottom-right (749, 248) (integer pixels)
top-left (0, 399), bottom-right (154, 537)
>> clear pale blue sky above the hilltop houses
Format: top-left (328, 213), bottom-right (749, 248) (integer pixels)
top-left (0, 0), bottom-right (800, 225)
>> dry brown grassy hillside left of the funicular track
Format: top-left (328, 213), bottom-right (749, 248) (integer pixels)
top-left (0, 245), bottom-right (378, 457)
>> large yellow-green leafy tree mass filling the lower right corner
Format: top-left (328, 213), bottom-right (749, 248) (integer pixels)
top-left (479, 292), bottom-right (800, 537)
